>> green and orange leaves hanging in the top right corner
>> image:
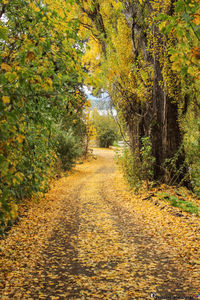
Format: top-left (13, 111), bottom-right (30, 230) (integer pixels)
top-left (158, 0), bottom-right (200, 81)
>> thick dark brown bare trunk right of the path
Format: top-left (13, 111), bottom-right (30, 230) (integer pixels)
top-left (151, 59), bottom-right (183, 178)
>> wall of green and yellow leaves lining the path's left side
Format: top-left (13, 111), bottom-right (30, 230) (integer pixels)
top-left (0, 0), bottom-right (85, 233)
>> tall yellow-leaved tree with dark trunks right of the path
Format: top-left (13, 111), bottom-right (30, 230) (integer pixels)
top-left (74, 0), bottom-right (199, 185)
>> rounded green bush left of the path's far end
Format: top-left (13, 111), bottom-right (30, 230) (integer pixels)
top-left (57, 130), bottom-right (83, 171)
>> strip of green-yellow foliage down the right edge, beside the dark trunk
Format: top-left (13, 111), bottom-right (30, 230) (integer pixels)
top-left (158, 0), bottom-right (200, 197)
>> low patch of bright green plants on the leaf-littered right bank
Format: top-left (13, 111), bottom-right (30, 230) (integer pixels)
top-left (158, 193), bottom-right (200, 214)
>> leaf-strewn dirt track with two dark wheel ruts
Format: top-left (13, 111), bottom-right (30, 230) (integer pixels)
top-left (2, 149), bottom-right (199, 300)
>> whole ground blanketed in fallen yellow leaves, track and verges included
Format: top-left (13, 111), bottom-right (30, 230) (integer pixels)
top-left (0, 149), bottom-right (200, 300)
